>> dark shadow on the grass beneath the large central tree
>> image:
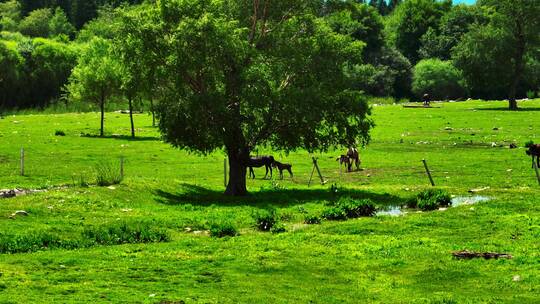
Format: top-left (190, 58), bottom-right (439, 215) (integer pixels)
top-left (154, 184), bottom-right (406, 208)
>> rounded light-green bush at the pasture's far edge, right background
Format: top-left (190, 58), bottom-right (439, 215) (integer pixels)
top-left (412, 59), bottom-right (467, 100)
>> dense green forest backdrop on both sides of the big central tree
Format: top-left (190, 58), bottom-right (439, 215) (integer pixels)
top-left (0, 0), bottom-right (540, 109)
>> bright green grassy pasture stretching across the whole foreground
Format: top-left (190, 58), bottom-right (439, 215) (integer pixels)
top-left (0, 100), bottom-right (540, 303)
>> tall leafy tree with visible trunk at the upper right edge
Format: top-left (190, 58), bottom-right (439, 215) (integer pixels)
top-left (453, 0), bottom-right (540, 110)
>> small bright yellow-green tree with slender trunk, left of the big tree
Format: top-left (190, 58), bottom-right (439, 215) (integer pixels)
top-left (67, 37), bottom-right (121, 136)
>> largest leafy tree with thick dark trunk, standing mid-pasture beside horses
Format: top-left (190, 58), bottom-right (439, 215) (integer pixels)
top-left (130, 0), bottom-right (372, 195)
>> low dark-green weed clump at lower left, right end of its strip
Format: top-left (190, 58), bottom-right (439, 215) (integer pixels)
top-left (83, 222), bottom-right (170, 245)
